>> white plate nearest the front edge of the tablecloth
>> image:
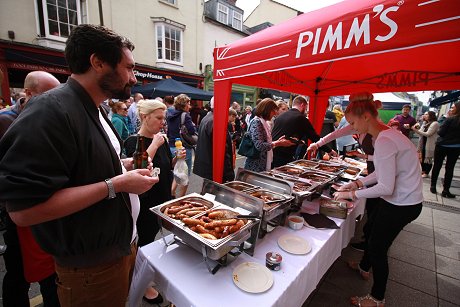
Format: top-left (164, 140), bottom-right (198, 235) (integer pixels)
top-left (233, 262), bottom-right (273, 293)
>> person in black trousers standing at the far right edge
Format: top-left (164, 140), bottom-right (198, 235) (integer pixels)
top-left (430, 102), bottom-right (460, 198)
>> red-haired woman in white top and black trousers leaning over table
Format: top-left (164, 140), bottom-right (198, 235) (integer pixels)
top-left (334, 92), bottom-right (423, 306)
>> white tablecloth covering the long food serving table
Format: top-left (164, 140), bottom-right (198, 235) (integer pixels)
top-left (129, 200), bottom-right (365, 307)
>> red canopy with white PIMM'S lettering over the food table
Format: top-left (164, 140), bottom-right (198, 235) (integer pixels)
top-left (213, 0), bottom-right (460, 182)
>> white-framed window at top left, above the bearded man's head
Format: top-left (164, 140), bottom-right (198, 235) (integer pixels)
top-left (39, 0), bottom-right (81, 41)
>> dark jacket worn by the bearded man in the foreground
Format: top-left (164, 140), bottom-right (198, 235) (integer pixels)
top-left (0, 78), bottom-right (133, 267)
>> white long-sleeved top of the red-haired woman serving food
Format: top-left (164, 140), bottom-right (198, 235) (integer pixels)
top-left (356, 129), bottom-right (423, 206)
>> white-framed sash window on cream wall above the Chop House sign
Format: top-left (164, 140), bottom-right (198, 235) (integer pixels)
top-left (156, 24), bottom-right (183, 64)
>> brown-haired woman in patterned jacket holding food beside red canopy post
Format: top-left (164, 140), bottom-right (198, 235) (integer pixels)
top-left (244, 98), bottom-right (294, 172)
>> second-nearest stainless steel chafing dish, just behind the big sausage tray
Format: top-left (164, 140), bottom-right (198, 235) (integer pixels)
top-left (236, 168), bottom-right (294, 237)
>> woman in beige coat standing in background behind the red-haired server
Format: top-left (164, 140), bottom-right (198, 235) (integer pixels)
top-left (412, 111), bottom-right (439, 178)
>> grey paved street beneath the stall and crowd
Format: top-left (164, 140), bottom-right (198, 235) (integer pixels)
top-left (0, 157), bottom-right (460, 307)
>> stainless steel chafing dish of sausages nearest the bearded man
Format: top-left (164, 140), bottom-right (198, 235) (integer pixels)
top-left (150, 189), bottom-right (264, 274)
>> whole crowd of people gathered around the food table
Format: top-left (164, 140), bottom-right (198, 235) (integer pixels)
top-left (0, 25), bottom-right (460, 307)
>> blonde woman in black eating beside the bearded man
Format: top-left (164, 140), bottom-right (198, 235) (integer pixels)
top-left (124, 100), bottom-right (175, 304)
